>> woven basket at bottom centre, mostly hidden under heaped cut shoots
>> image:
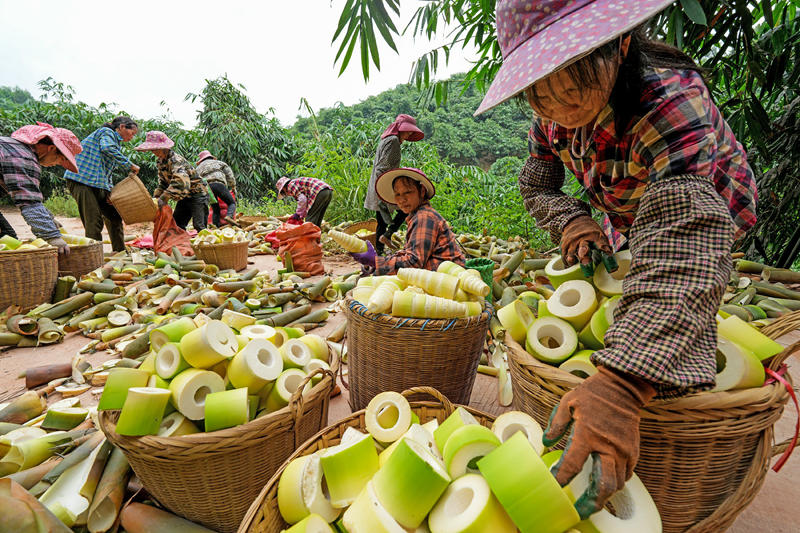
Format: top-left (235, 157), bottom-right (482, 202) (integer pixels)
top-left (238, 387), bottom-right (494, 533)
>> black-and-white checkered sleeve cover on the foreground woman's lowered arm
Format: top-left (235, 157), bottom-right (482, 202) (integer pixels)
top-left (592, 175), bottom-right (733, 397)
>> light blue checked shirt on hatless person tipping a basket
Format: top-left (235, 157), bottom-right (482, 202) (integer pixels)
top-left (64, 127), bottom-right (131, 191)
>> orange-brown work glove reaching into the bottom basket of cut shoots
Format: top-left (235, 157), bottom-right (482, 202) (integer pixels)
top-left (542, 366), bottom-right (655, 519)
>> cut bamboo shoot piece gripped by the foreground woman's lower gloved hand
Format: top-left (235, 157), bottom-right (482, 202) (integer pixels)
top-left (564, 457), bottom-right (662, 533)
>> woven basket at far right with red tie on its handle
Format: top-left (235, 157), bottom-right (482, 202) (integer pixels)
top-left (507, 323), bottom-right (800, 533)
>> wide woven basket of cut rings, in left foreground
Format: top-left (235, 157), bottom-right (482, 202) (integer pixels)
top-left (99, 351), bottom-right (339, 533)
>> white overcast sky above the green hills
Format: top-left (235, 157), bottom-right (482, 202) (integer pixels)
top-left (0, 0), bottom-right (470, 126)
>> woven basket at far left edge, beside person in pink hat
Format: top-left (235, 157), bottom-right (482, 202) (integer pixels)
top-left (0, 247), bottom-right (58, 310)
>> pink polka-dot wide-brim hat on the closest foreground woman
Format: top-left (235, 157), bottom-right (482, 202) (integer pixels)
top-left (475, 0), bottom-right (675, 115)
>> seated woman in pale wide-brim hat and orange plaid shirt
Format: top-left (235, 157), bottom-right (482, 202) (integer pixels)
top-left (350, 168), bottom-right (464, 274)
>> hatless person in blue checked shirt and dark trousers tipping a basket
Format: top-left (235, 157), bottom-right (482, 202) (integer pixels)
top-left (64, 115), bottom-right (139, 252)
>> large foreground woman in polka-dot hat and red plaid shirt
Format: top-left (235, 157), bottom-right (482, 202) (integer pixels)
top-left (476, 0), bottom-right (756, 518)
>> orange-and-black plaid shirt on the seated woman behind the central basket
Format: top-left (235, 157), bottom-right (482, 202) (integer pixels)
top-left (375, 202), bottom-right (465, 274)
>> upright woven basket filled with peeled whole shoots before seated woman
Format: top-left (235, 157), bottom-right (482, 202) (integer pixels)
top-left (346, 297), bottom-right (492, 411)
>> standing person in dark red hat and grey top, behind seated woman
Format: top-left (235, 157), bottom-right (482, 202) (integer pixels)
top-left (364, 114), bottom-right (425, 255)
